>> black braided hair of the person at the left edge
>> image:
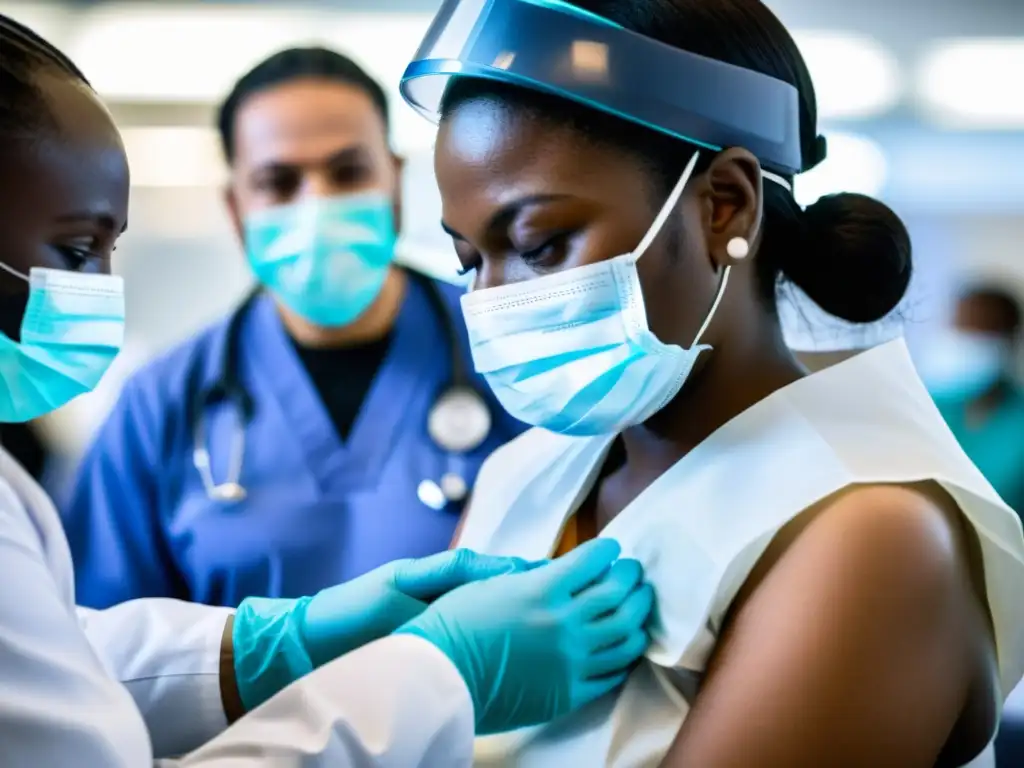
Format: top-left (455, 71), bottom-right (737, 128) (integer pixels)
top-left (0, 13), bottom-right (89, 138)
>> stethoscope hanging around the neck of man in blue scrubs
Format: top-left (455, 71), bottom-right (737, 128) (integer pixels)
top-left (187, 270), bottom-right (492, 511)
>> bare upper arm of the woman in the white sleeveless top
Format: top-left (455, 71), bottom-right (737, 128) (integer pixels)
top-left (665, 487), bottom-right (994, 768)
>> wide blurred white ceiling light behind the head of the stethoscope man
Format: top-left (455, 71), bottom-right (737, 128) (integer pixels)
top-left (69, 3), bottom-right (436, 152)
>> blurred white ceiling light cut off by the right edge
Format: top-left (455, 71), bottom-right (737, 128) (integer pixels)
top-left (918, 38), bottom-right (1024, 130)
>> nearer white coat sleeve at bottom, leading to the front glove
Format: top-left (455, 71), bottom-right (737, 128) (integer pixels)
top-left (165, 636), bottom-right (474, 768)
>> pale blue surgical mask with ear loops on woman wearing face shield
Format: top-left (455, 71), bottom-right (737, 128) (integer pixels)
top-left (462, 154), bottom-right (770, 435)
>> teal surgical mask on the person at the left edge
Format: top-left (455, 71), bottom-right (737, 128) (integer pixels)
top-left (0, 263), bottom-right (125, 423)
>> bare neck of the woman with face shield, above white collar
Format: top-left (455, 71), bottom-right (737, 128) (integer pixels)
top-left (623, 324), bottom-right (805, 480)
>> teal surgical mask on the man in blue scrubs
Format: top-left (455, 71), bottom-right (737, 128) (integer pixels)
top-left (245, 193), bottom-right (396, 328)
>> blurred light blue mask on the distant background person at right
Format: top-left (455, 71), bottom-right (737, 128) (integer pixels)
top-left (914, 329), bottom-right (1012, 401)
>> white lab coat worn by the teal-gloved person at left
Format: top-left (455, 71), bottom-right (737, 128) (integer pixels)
top-left (0, 450), bottom-right (473, 768)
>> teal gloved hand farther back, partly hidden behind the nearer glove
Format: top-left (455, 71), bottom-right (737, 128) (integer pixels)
top-left (231, 550), bottom-right (532, 710)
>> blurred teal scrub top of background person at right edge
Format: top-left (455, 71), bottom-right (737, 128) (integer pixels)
top-left (935, 388), bottom-right (1024, 515)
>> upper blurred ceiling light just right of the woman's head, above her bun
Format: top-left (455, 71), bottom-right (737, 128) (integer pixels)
top-left (794, 32), bottom-right (902, 120)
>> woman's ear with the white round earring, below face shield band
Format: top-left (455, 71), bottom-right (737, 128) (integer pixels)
top-left (705, 147), bottom-right (762, 267)
